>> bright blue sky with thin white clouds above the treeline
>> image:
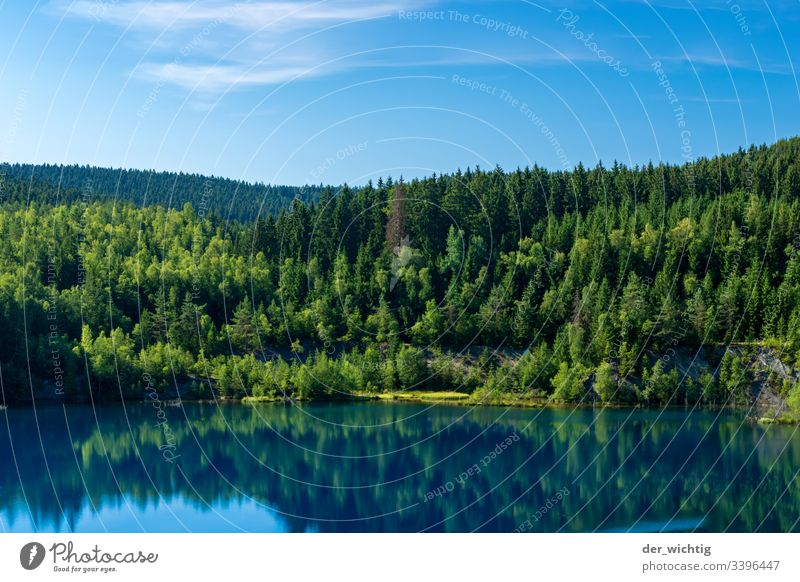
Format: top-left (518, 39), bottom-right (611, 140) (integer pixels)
top-left (0, 0), bottom-right (800, 184)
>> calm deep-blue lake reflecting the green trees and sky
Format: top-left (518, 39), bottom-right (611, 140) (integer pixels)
top-left (0, 403), bottom-right (800, 532)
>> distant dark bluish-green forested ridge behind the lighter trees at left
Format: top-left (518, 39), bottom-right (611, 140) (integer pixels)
top-left (0, 164), bottom-right (322, 222)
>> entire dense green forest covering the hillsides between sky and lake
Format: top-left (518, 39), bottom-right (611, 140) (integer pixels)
top-left (0, 139), bottom-right (800, 418)
